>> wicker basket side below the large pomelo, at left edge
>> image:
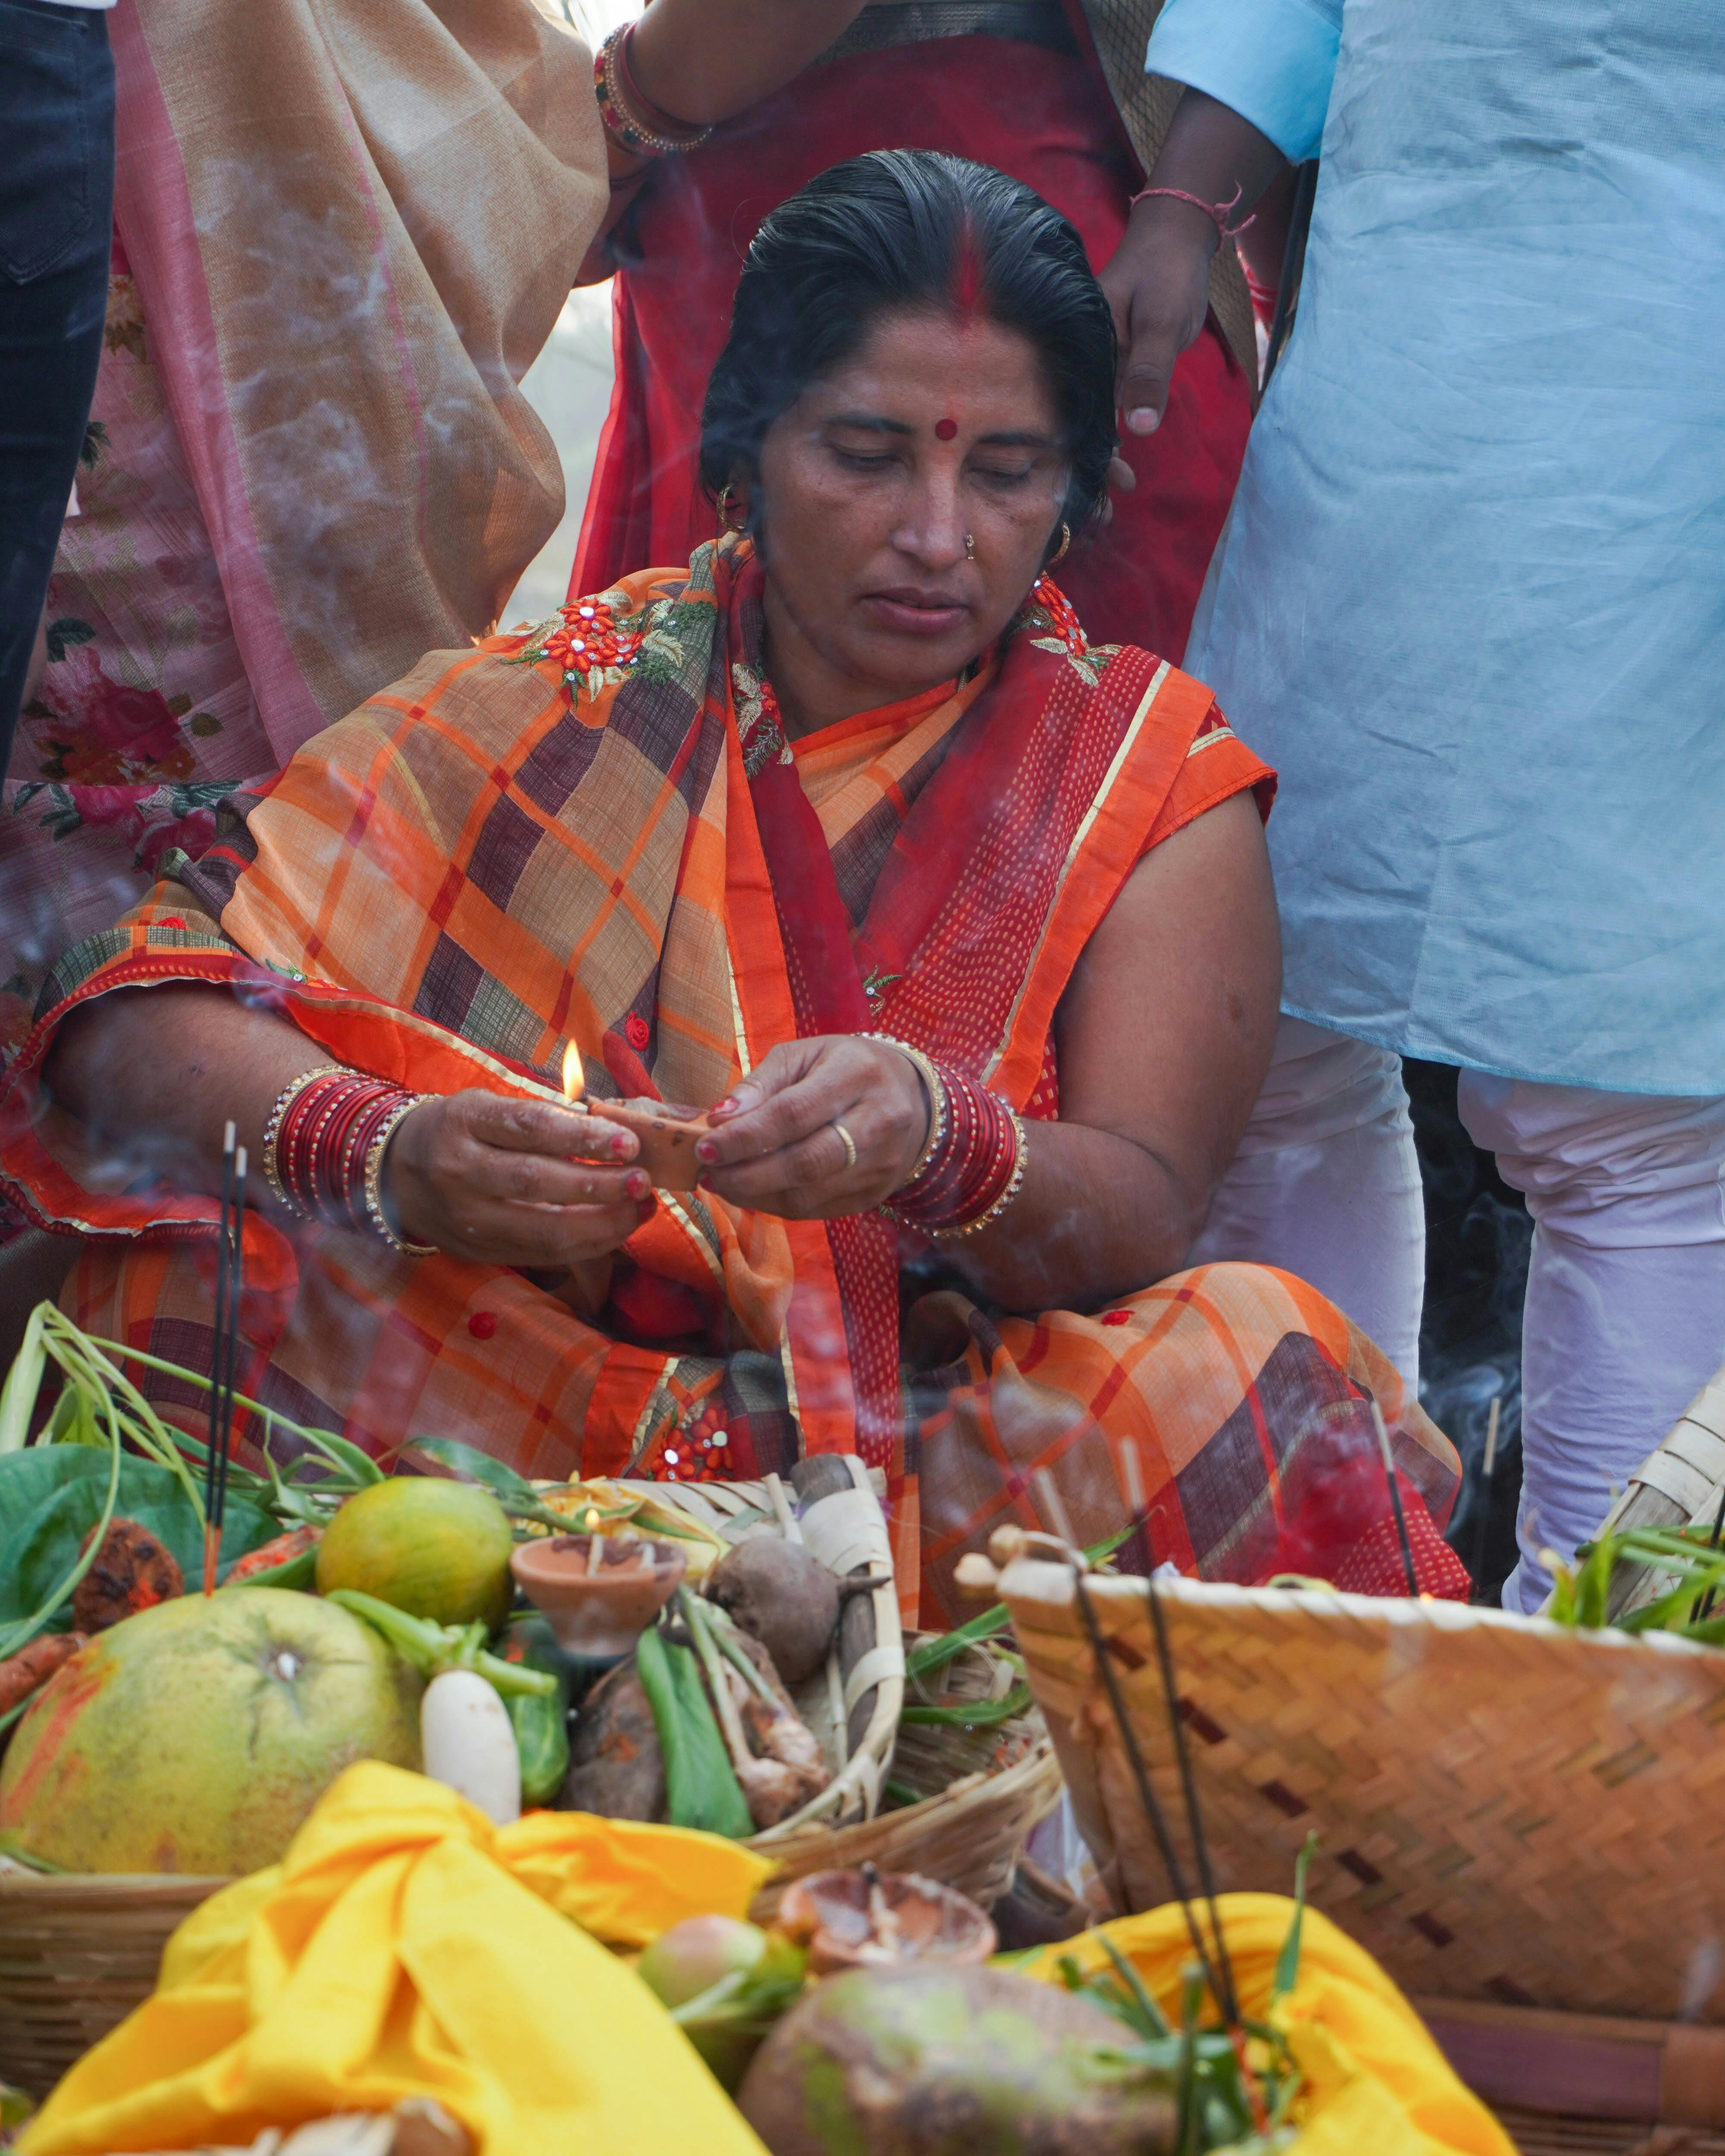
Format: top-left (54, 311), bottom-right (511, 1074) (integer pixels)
top-left (0, 1874), bottom-right (226, 2096)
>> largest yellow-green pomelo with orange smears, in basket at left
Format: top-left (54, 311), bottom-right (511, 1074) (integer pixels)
top-left (0, 1587), bottom-right (420, 1876)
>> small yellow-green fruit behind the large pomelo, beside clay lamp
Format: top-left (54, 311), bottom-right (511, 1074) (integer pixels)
top-left (317, 1475), bottom-right (515, 1630)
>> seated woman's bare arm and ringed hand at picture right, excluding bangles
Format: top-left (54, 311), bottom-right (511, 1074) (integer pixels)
top-left (696, 793), bottom-right (1281, 1311)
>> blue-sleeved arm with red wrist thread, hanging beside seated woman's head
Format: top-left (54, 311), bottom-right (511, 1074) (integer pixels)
top-left (1102, 0), bottom-right (1341, 433)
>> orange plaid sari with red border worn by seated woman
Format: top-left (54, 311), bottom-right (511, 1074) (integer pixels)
top-left (0, 541), bottom-right (1455, 1619)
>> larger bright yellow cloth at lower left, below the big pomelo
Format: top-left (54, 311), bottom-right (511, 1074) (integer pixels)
top-left (19, 1761), bottom-right (770, 2156)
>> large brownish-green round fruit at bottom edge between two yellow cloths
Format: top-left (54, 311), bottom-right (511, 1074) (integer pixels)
top-left (737, 1962), bottom-right (1175, 2156)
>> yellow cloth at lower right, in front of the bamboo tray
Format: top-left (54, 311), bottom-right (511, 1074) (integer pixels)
top-left (1016, 1893), bottom-right (1516, 2156)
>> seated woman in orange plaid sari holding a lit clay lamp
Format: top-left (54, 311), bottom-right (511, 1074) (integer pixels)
top-left (0, 153), bottom-right (1455, 1621)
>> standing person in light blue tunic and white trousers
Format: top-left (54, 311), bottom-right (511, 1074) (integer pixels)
top-left (1104, 0), bottom-right (1725, 1608)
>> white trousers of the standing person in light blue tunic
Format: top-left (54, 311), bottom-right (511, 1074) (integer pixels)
top-left (1195, 1018), bottom-right (1725, 1611)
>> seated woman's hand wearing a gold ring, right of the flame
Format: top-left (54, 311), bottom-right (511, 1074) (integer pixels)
top-left (694, 1033), bottom-right (932, 1220)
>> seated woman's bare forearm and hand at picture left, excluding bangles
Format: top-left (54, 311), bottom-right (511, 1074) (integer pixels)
top-left (45, 985), bottom-right (653, 1270)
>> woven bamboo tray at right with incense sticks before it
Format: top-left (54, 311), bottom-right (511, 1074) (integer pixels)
top-left (1000, 1559), bottom-right (1725, 2022)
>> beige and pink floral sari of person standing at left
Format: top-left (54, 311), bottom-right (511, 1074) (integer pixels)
top-left (0, 0), bottom-right (606, 1367)
